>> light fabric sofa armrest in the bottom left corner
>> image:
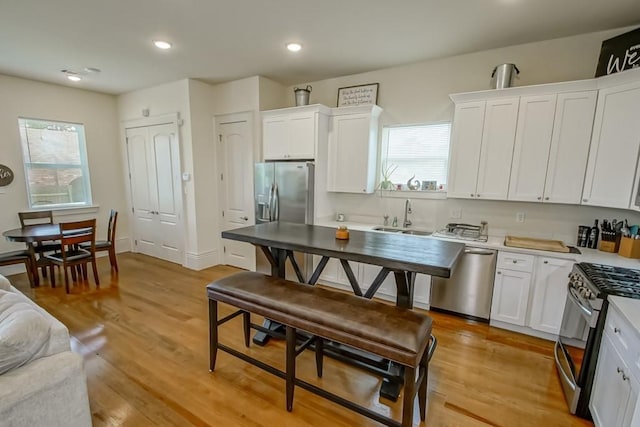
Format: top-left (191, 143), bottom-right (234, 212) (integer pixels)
top-left (0, 351), bottom-right (91, 427)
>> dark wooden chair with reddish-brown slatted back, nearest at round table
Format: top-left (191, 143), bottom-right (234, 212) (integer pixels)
top-left (45, 218), bottom-right (100, 293)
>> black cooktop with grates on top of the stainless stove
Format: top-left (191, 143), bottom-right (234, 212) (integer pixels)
top-left (578, 262), bottom-right (640, 299)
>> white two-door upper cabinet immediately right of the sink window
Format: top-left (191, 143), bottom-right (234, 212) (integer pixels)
top-left (447, 98), bottom-right (519, 200)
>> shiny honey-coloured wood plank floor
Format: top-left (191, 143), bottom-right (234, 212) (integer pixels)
top-left (10, 253), bottom-right (592, 427)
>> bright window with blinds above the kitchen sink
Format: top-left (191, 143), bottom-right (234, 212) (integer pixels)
top-left (381, 123), bottom-right (451, 190)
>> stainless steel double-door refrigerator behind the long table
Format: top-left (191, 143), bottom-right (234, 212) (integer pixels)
top-left (254, 162), bottom-right (314, 280)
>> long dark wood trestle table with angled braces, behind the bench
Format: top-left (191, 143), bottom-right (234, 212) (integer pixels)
top-left (222, 221), bottom-right (464, 400)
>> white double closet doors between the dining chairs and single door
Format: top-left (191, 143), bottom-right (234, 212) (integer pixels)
top-left (126, 123), bottom-right (184, 264)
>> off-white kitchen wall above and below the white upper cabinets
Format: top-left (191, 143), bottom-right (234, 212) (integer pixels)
top-left (281, 28), bottom-right (640, 242)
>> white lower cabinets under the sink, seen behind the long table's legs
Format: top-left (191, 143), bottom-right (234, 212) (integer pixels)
top-left (313, 256), bottom-right (431, 308)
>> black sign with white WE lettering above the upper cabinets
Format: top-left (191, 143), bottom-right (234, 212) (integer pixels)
top-left (596, 28), bottom-right (640, 77)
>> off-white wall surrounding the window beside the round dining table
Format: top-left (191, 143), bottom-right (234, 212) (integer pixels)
top-left (0, 75), bottom-right (129, 274)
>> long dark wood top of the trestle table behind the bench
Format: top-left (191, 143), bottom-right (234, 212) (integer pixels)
top-left (222, 221), bottom-right (464, 278)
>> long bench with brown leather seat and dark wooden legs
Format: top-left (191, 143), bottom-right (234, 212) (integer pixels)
top-left (207, 272), bottom-right (436, 427)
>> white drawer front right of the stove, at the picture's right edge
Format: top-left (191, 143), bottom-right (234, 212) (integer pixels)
top-left (604, 305), bottom-right (640, 378)
